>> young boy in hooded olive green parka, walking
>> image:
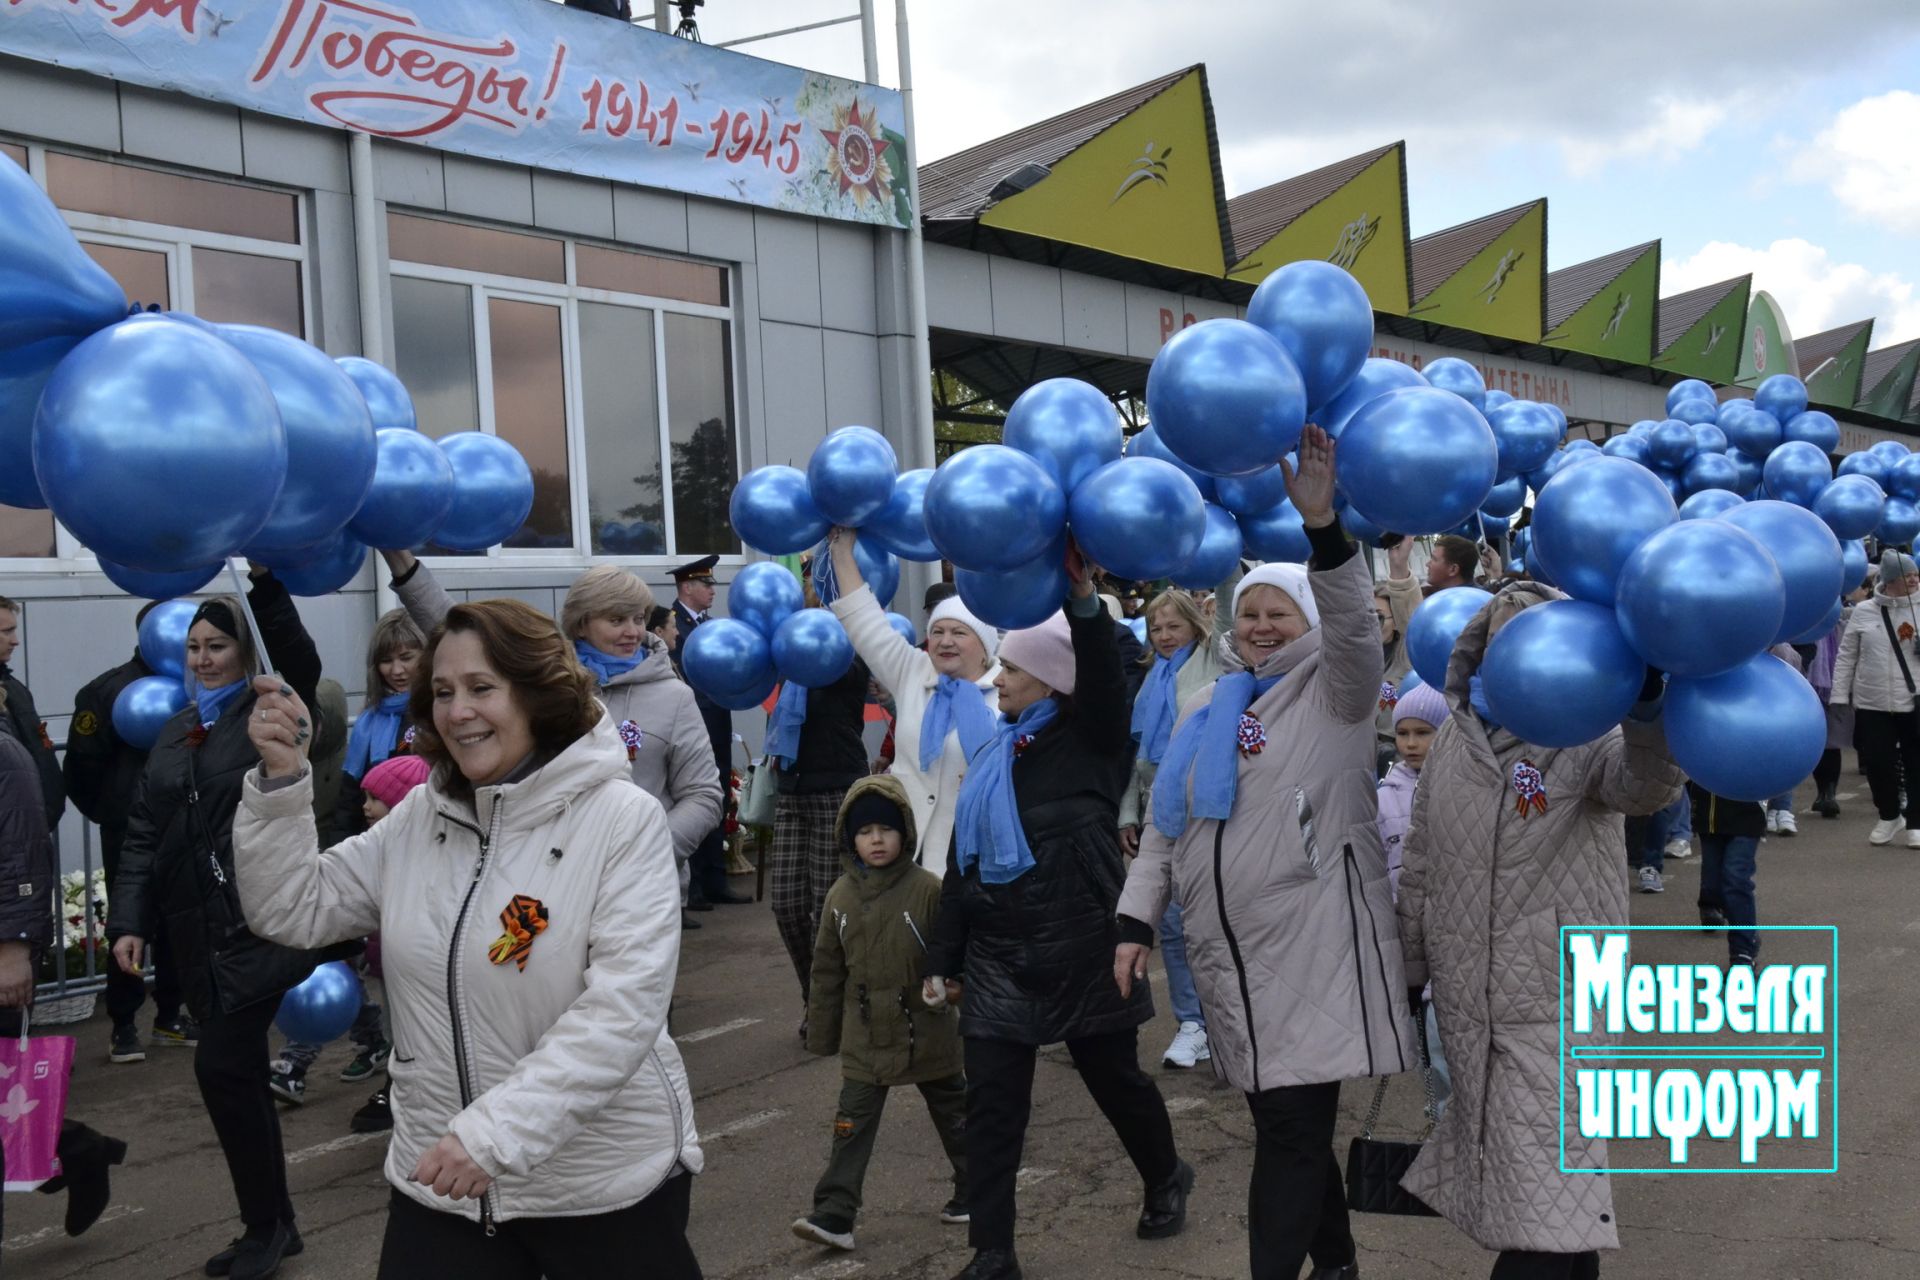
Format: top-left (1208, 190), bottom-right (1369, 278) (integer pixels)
top-left (793, 777), bottom-right (968, 1249)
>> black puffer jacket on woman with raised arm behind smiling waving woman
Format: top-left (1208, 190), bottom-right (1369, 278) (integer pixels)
top-left (108, 574), bottom-right (321, 1019)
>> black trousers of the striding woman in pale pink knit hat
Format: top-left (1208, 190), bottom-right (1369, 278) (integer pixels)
top-left (966, 1027), bottom-right (1179, 1249)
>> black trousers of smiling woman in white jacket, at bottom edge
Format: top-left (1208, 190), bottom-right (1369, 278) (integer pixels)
top-left (378, 1173), bottom-right (701, 1280)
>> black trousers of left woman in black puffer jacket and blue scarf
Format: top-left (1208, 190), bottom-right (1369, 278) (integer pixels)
top-left (194, 996), bottom-right (294, 1226)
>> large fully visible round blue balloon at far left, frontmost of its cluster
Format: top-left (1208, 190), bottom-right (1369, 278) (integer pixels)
top-left (33, 317), bottom-right (286, 572)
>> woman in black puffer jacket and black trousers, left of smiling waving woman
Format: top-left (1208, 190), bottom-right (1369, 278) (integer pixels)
top-left (108, 568), bottom-right (321, 1280)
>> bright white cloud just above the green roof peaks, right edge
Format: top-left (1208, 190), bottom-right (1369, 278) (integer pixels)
top-left (1661, 240), bottom-right (1920, 347)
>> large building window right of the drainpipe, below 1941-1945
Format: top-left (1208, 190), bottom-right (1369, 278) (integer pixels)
top-left (388, 213), bottom-right (739, 557)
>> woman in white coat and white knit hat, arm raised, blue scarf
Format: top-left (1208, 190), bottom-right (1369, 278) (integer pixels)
top-left (828, 530), bottom-right (1000, 875)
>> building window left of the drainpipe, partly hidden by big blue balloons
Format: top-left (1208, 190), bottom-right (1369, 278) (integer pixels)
top-left (0, 142), bottom-right (311, 558)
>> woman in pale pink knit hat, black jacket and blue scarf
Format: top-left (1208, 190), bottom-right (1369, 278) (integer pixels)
top-left (925, 545), bottom-right (1194, 1280)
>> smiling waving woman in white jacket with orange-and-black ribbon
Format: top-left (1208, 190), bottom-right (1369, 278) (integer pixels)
top-left (234, 601), bottom-right (705, 1280)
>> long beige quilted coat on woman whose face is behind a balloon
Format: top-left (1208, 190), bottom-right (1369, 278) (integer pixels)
top-left (1400, 583), bottom-right (1682, 1253)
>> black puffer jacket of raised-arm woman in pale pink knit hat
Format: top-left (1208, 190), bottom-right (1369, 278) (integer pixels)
top-left (925, 608), bottom-right (1154, 1044)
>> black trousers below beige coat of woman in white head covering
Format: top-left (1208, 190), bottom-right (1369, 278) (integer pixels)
top-left (1246, 1080), bottom-right (1354, 1280)
